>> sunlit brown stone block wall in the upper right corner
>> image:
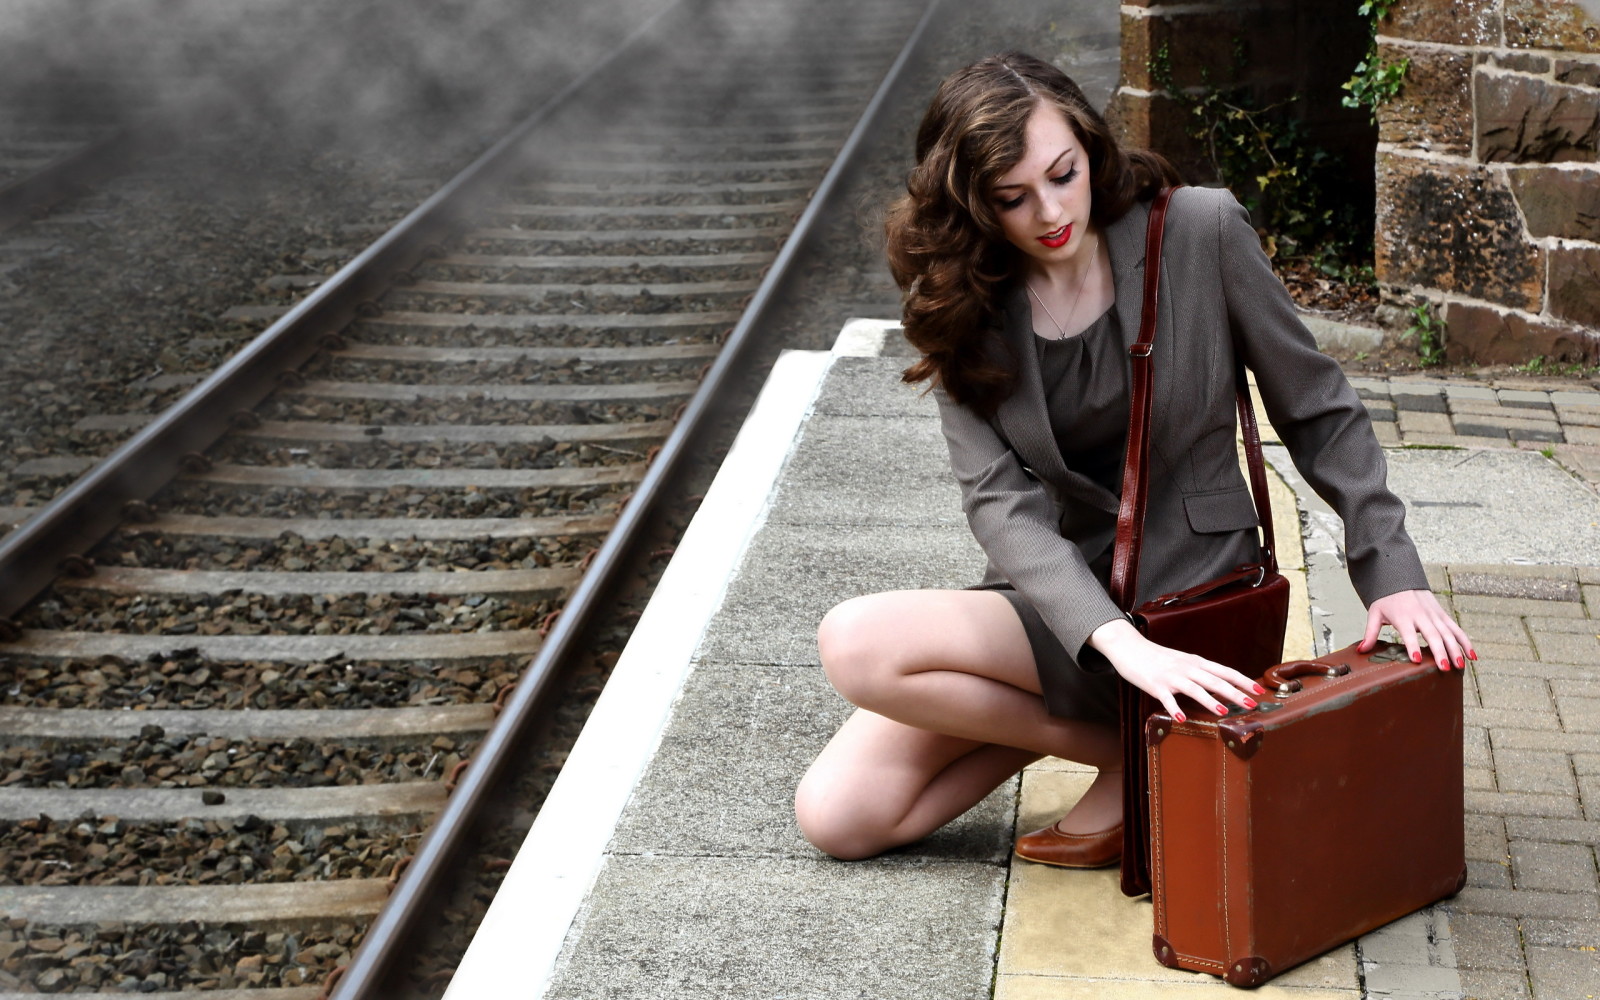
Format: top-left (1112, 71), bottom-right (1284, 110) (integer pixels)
top-left (1376, 0), bottom-right (1600, 363)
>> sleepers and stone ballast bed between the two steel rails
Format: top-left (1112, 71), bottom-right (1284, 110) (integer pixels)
top-left (0, 0), bottom-right (922, 1000)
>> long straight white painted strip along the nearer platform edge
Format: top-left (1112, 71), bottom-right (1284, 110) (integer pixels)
top-left (445, 350), bottom-right (835, 1000)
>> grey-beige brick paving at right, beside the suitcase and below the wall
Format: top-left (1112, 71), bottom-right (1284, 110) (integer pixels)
top-left (1350, 376), bottom-right (1600, 1000)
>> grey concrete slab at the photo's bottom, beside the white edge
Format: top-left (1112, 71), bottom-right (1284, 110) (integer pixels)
top-left (546, 858), bottom-right (1005, 1000)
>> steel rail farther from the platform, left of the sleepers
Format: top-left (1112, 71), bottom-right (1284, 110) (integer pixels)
top-left (0, 0), bottom-right (683, 632)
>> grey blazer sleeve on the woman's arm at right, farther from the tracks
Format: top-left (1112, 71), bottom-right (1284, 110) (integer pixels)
top-left (1216, 192), bottom-right (1427, 605)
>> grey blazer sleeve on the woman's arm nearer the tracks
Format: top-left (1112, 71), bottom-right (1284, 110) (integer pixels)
top-left (933, 387), bottom-right (1122, 672)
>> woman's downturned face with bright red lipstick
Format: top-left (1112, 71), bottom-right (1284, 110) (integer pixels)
top-left (990, 102), bottom-right (1091, 267)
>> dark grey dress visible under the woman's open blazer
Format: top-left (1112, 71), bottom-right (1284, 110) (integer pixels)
top-left (1000, 309), bottom-right (1128, 722)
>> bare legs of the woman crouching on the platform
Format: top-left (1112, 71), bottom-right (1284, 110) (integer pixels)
top-left (795, 590), bottom-right (1122, 858)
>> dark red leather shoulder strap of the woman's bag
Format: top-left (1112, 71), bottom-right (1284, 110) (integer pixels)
top-left (1110, 187), bottom-right (1278, 611)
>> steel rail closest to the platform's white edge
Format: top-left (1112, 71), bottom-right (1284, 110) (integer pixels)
top-left (328, 0), bottom-right (941, 1000)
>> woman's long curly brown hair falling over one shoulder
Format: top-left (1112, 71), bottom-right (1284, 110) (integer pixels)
top-left (885, 51), bottom-right (1179, 416)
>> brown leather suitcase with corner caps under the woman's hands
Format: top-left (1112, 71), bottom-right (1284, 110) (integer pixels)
top-left (1146, 643), bottom-right (1466, 987)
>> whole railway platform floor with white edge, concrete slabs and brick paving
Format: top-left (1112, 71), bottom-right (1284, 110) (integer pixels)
top-left (446, 320), bottom-right (1600, 1000)
